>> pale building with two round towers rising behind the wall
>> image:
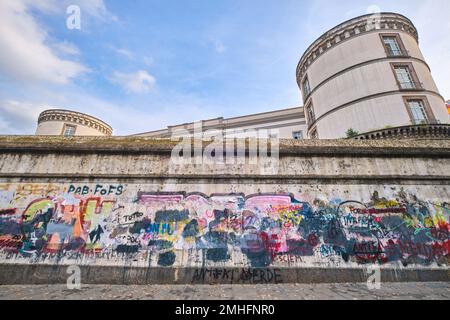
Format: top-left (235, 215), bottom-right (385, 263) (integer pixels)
top-left (32, 13), bottom-right (450, 139)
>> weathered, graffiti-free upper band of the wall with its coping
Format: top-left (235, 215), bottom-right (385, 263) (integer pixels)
top-left (0, 137), bottom-right (450, 180)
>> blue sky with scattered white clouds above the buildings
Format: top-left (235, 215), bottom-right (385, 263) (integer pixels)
top-left (0, 0), bottom-right (450, 135)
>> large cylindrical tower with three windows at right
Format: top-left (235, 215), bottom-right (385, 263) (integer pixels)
top-left (297, 13), bottom-right (450, 139)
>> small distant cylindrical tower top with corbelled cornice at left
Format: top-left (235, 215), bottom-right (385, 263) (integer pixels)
top-left (36, 109), bottom-right (112, 137)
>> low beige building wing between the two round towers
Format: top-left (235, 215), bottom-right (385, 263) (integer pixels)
top-left (136, 107), bottom-right (307, 139)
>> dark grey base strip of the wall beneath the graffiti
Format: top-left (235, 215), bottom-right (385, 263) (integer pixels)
top-left (0, 265), bottom-right (450, 285)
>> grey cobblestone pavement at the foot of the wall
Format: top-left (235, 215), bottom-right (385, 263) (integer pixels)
top-left (0, 282), bottom-right (450, 300)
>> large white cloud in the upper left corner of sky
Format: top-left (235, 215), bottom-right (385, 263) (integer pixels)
top-left (0, 0), bottom-right (88, 84)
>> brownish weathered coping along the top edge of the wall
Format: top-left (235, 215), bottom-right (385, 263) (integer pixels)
top-left (0, 136), bottom-right (450, 157)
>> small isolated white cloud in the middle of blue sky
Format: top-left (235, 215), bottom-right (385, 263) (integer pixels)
top-left (110, 70), bottom-right (156, 93)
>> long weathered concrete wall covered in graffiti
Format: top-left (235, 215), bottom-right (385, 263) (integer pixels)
top-left (0, 137), bottom-right (450, 283)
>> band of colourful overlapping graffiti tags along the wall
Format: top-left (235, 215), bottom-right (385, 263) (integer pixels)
top-left (0, 184), bottom-right (450, 268)
